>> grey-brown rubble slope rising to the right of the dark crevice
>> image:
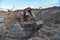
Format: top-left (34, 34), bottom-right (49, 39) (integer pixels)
top-left (30, 8), bottom-right (60, 40)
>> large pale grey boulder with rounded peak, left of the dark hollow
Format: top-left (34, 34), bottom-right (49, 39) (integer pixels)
top-left (7, 23), bottom-right (22, 38)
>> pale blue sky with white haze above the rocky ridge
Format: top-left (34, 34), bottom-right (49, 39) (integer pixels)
top-left (0, 0), bottom-right (60, 10)
